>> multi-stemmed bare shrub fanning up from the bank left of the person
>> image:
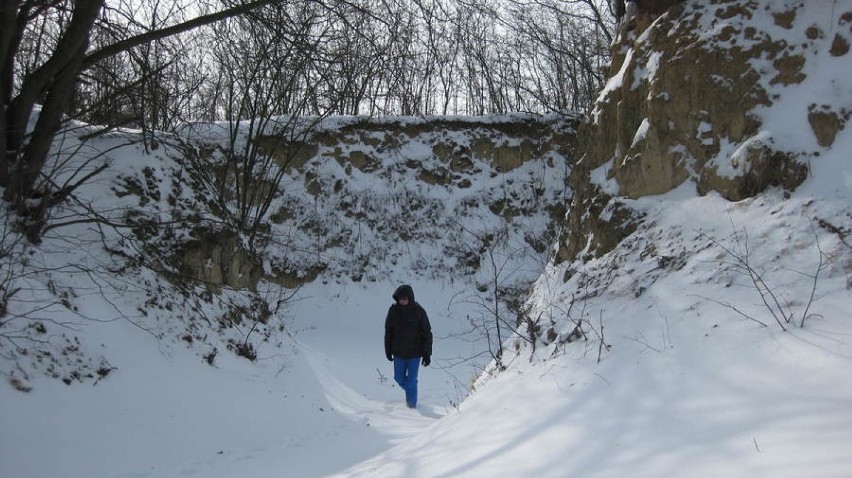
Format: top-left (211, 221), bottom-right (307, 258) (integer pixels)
top-left (181, 1), bottom-right (374, 248)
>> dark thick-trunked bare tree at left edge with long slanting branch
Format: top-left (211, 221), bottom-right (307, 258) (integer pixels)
top-left (0, 0), bottom-right (286, 241)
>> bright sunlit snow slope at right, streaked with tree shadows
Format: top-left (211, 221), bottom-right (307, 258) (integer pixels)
top-left (334, 194), bottom-right (852, 478)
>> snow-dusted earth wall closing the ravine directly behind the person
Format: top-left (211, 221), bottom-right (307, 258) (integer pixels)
top-left (169, 115), bottom-right (577, 290)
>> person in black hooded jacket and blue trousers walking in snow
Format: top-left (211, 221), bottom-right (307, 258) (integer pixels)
top-left (385, 284), bottom-right (432, 408)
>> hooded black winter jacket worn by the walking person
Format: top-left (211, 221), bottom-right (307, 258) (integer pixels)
top-left (385, 285), bottom-right (432, 359)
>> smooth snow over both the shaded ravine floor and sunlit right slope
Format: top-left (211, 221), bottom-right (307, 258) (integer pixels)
top-left (0, 188), bottom-right (852, 478)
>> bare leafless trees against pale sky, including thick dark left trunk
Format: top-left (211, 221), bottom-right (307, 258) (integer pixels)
top-left (0, 0), bottom-right (616, 241)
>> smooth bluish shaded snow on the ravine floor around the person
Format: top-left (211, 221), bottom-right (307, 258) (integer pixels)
top-left (0, 283), bottom-right (486, 478)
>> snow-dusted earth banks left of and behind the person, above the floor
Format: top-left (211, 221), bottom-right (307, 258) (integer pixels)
top-left (0, 115), bottom-right (573, 388)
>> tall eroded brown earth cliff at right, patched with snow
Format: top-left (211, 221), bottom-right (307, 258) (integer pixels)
top-left (559, 0), bottom-right (852, 261)
